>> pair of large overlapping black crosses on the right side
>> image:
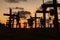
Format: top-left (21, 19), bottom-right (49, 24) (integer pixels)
top-left (36, 0), bottom-right (60, 28)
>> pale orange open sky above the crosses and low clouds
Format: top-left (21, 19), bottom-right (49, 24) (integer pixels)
top-left (0, 0), bottom-right (60, 23)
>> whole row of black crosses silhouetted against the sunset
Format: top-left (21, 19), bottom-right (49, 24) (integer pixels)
top-left (4, 0), bottom-right (60, 29)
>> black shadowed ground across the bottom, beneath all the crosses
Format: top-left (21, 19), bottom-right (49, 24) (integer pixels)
top-left (0, 28), bottom-right (60, 40)
